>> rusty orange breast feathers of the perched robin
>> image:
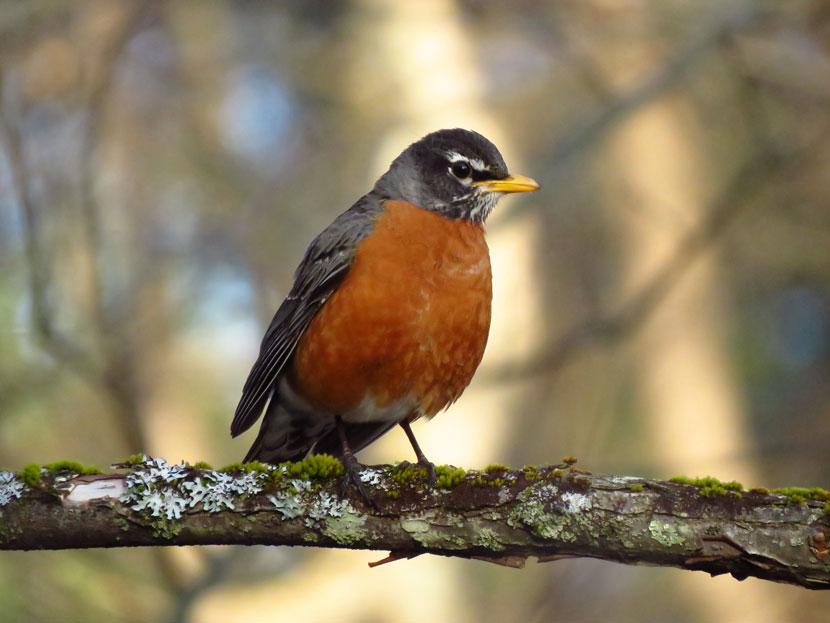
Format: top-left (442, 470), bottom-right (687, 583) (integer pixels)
top-left (292, 201), bottom-right (492, 417)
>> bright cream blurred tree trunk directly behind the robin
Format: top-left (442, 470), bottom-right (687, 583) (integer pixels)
top-left (190, 0), bottom-right (539, 621)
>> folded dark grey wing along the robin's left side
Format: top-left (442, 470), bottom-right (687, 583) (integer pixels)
top-left (231, 194), bottom-right (382, 437)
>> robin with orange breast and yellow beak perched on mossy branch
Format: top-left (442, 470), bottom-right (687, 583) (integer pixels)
top-left (231, 129), bottom-right (539, 491)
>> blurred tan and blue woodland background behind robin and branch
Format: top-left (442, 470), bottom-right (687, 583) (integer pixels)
top-left (0, 0), bottom-right (830, 623)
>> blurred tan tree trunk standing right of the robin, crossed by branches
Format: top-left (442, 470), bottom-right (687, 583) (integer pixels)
top-left (604, 30), bottom-right (782, 623)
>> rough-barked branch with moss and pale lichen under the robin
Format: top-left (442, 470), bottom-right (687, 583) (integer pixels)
top-left (0, 457), bottom-right (830, 589)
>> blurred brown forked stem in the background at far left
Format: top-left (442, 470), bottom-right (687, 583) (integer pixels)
top-left (0, 3), bottom-right (185, 595)
